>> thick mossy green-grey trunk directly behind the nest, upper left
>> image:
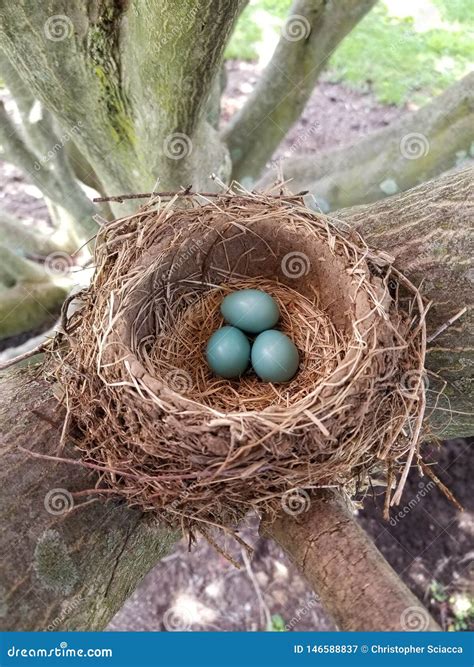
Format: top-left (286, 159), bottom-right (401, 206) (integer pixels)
top-left (0, 0), bottom-right (246, 204)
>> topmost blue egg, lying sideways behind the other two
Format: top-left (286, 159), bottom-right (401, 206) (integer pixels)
top-left (221, 289), bottom-right (280, 333)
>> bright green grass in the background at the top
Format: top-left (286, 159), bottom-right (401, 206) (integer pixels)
top-left (226, 0), bottom-right (474, 105)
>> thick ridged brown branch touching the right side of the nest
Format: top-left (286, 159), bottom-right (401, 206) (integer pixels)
top-left (334, 168), bottom-right (474, 440)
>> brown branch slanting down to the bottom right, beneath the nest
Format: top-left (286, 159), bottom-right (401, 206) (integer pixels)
top-left (260, 491), bottom-right (440, 632)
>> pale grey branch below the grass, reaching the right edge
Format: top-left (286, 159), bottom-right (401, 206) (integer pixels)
top-left (259, 73), bottom-right (474, 210)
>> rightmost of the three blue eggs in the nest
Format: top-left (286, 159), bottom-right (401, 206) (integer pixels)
top-left (251, 329), bottom-right (299, 382)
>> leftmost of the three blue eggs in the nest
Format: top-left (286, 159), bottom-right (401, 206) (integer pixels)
top-left (206, 327), bottom-right (250, 378)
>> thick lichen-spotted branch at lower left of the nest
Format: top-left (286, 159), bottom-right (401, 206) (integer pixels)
top-left (0, 371), bottom-right (175, 630)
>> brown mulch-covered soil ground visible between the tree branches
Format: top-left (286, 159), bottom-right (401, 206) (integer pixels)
top-left (0, 62), bottom-right (474, 631)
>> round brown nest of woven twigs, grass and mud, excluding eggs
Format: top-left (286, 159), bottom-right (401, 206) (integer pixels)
top-left (55, 187), bottom-right (425, 531)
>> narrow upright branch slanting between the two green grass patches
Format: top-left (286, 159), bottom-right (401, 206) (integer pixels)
top-left (222, 0), bottom-right (376, 181)
